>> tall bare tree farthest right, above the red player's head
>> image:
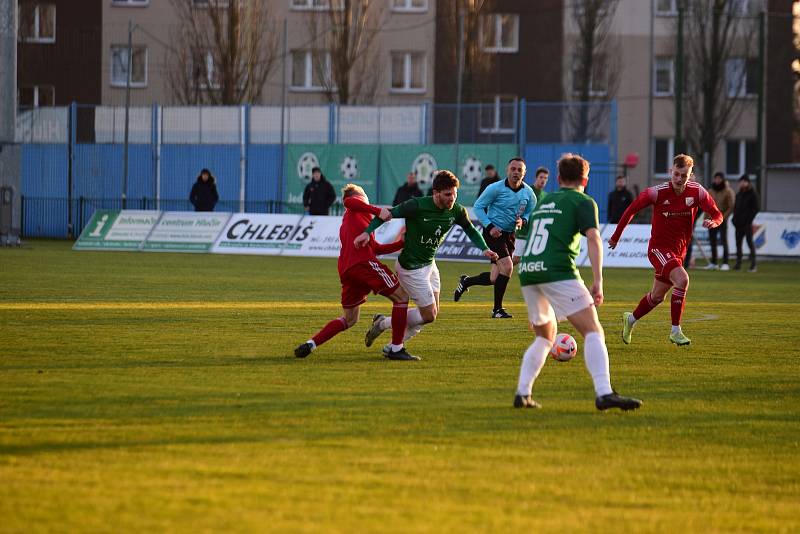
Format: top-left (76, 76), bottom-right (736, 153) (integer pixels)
top-left (678, 0), bottom-right (760, 175)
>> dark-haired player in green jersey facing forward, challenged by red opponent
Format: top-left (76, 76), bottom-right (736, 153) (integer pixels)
top-left (354, 170), bottom-right (497, 357)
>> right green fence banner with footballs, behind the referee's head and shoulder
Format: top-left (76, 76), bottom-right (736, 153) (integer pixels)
top-left (378, 145), bottom-right (518, 206)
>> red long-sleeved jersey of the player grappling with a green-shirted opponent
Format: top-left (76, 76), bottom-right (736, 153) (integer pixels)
top-left (339, 199), bottom-right (403, 276)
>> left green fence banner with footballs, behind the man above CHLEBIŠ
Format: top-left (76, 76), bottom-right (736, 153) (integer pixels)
top-left (285, 145), bottom-right (379, 208)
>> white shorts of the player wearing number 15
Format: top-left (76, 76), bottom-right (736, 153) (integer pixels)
top-left (522, 280), bottom-right (594, 326)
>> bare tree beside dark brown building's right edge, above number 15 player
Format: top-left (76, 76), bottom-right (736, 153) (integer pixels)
top-left (569, 0), bottom-right (620, 142)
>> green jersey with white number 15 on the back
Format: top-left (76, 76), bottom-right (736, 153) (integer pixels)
top-left (519, 188), bottom-right (599, 286)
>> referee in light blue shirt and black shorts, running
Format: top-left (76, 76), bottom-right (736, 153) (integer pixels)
top-left (453, 158), bottom-right (536, 319)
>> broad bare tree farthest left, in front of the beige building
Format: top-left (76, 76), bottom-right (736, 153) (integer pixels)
top-left (168, 0), bottom-right (279, 105)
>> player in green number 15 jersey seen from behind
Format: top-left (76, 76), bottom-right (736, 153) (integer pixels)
top-left (514, 154), bottom-right (642, 410)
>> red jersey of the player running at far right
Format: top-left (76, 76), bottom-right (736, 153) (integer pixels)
top-left (610, 181), bottom-right (722, 258)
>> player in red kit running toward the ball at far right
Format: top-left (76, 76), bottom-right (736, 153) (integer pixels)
top-left (608, 154), bottom-right (722, 346)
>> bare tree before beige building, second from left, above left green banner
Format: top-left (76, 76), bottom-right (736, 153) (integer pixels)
top-left (308, 0), bottom-right (386, 104)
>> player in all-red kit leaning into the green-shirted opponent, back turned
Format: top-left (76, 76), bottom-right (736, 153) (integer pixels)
top-left (294, 184), bottom-right (419, 360)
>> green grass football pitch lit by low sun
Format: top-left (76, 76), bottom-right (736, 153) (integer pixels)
top-left (0, 241), bottom-right (800, 532)
